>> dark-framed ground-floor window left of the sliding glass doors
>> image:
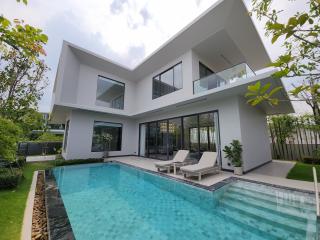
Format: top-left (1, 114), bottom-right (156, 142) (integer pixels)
top-left (91, 121), bottom-right (122, 152)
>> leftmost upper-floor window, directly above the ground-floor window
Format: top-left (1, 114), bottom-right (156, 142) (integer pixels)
top-left (96, 76), bottom-right (125, 109)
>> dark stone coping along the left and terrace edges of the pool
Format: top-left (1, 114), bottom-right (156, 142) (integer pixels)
top-left (45, 161), bottom-right (314, 240)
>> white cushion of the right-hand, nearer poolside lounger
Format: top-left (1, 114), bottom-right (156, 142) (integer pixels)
top-left (180, 152), bottom-right (218, 172)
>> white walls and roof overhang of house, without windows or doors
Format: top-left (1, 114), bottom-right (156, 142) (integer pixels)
top-left (51, 0), bottom-right (293, 171)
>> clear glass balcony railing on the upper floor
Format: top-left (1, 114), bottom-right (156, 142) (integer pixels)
top-left (193, 63), bottom-right (255, 94)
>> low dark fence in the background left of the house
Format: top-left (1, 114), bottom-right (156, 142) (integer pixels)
top-left (18, 142), bottom-right (62, 156)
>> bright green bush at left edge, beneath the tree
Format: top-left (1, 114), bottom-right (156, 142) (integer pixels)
top-left (0, 117), bottom-right (21, 161)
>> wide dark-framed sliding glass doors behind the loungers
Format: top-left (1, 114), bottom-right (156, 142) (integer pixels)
top-left (139, 112), bottom-right (219, 160)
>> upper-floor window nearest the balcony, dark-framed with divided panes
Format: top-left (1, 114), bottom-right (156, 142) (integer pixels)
top-left (152, 62), bottom-right (182, 99)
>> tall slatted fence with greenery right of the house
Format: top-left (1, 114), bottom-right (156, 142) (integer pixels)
top-left (268, 116), bottom-right (320, 161)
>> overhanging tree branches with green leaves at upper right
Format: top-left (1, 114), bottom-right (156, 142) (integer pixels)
top-left (246, 0), bottom-right (320, 123)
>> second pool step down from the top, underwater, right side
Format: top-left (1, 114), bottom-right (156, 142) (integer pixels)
top-left (223, 189), bottom-right (316, 221)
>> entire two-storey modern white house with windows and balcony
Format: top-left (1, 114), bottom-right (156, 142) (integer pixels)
top-left (51, 0), bottom-right (294, 172)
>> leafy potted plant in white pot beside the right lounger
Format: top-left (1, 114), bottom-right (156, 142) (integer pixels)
top-left (223, 140), bottom-right (243, 175)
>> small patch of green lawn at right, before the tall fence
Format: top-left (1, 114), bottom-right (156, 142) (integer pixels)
top-left (287, 162), bottom-right (320, 182)
